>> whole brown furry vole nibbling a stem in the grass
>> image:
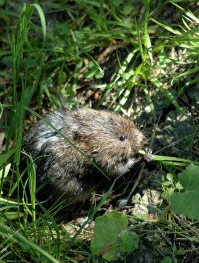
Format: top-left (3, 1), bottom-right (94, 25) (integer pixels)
top-left (24, 109), bottom-right (151, 205)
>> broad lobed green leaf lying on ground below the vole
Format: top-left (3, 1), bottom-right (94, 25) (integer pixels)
top-left (91, 212), bottom-right (139, 260)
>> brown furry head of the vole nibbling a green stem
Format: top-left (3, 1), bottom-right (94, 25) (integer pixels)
top-left (71, 109), bottom-right (151, 176)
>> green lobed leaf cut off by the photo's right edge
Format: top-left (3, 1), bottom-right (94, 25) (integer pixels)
top-left (170, 164), bottom-right (199, 219)
